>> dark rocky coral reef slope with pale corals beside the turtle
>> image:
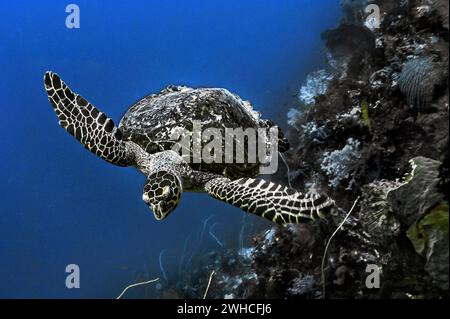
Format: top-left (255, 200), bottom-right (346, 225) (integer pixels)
top-left (153, 0), bottom-right (449, 299)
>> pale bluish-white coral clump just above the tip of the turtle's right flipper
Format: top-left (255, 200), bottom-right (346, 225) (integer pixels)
top-left (320, 138), bottom-right (361, 189)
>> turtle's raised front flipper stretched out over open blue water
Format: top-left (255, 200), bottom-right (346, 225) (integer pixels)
top-left (44, 72), bottom-right (134, 166)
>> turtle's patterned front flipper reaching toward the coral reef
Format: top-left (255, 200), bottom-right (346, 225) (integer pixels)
top-left (205, 177), bottom-right (334, 224)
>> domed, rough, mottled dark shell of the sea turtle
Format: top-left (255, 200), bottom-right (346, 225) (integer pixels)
top-left (119, 86), bottom-right (263, 178)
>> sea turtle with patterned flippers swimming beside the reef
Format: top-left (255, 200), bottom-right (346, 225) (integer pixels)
top-left (44, 72), bottom-right (334, 224)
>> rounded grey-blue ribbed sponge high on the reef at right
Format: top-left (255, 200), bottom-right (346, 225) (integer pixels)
top-left (398, 57), bottom-right (444, 110)
